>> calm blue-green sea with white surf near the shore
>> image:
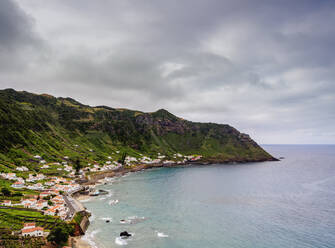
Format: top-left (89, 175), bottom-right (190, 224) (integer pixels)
top-left (84, 145), bottom-right (335, 248)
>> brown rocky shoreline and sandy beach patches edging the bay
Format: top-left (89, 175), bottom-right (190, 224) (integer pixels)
top-left (70, 158), bottom-right (279, 248)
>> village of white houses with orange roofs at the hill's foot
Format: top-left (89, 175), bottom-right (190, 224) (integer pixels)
top-left (0, 151), bottom-right (201, 240)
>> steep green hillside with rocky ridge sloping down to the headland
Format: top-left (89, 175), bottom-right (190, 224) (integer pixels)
top-left (0, 89), bottom-right (273, 170)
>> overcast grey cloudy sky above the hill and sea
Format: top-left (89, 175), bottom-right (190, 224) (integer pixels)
top-left (0, 0), bottom-right (335, 144)
